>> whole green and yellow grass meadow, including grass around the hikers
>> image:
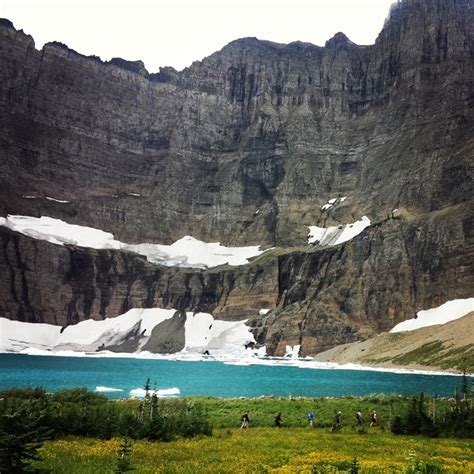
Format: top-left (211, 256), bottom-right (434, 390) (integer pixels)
top-left (27, 395), bottom-right (474, 474)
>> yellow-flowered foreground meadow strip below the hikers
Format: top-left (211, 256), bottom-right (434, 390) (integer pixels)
top-left (37, 427), bottom-right (474, 474)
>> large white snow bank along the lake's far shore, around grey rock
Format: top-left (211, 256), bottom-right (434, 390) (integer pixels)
top-left (0, 308), bottom-right (255, 357)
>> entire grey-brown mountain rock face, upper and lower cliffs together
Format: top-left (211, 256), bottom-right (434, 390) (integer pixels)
top-left (0, 0), bottom-right (474, 354)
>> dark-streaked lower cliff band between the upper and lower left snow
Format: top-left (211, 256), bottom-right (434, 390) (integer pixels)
top-left (0, 227), bottom-right (278, 326)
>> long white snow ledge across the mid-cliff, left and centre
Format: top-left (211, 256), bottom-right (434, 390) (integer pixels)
top-left (0, 216), bottom-right (262, 268)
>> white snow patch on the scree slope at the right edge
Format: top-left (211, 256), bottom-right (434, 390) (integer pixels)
top-left (390, 298), bottom-right (474, 332)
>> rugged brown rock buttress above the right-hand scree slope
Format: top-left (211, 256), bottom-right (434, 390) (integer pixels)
top-left (251, 205), bottom-right (474, 355)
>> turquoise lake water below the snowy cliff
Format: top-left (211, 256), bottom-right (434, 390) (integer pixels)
top-left (0, 354), bottom-right (466, 398)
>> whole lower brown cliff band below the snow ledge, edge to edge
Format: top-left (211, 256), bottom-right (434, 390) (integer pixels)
top-left (0, 199), bottom-right (474, 355)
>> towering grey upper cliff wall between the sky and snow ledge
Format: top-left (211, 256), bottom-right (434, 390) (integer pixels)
top-left (0, 0), bottom-right (472, 245)
